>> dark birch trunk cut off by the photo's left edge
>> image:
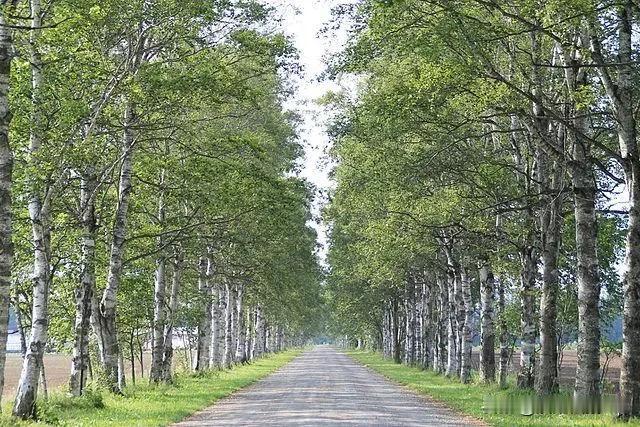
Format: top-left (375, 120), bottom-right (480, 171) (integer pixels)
top-left (0, 6), bottom-right (13, 410)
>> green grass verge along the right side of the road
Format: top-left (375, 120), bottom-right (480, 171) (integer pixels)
top-left (347, 351), bottom-right (640, 427)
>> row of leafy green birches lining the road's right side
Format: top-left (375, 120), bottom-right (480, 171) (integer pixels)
top-left (326, 0), bottom-right (640, 417)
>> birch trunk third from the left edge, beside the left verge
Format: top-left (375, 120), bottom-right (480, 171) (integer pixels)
top-left (69, 168), bottom-right (98, 396)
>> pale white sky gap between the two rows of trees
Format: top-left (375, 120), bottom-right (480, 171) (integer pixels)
top-left (263, 0), bottom-right (356, 264)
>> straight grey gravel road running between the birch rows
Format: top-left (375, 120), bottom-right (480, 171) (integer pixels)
top-left (176, 346), bottom-right (483, 427)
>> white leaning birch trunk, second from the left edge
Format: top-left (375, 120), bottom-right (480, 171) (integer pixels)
top-left (13, 0), bottom-right (50, 418)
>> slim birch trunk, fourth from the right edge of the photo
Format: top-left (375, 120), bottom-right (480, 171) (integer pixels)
top-left (517, 246), bottom-right (537, 388)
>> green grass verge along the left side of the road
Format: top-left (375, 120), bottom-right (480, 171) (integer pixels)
top-left (0, 350), bottom-right (301, 427)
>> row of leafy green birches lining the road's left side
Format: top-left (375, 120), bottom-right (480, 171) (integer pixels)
top-left (0, 0), bottom-right (320, 418)
